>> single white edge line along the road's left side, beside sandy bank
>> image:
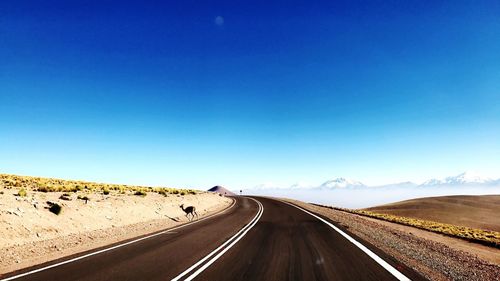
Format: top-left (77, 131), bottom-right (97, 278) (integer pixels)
top-left (0, 198), bottom-right (236, 281)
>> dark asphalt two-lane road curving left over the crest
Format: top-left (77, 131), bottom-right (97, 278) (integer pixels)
top-left (1, 197), bottom-right (422, 281)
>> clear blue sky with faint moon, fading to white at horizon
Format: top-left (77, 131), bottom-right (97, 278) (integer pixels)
top-left (0, 0), bottom-right (500, 188)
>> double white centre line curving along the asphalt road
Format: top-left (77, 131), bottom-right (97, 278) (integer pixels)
top-left (172, 197), bottom-right (264, 281)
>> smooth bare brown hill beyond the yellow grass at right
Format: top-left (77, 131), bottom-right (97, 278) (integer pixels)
top-left (365, 195), bottom-right (500, 231)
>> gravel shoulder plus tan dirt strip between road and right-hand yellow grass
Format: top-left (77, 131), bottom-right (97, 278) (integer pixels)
top-left (285, 197), bottom-right (500, 281)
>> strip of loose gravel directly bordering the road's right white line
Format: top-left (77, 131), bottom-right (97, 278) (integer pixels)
top-left (281, 199), bottom-right (500, 280)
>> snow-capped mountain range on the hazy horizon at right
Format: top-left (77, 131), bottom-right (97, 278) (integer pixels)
top-left (252, 172), bottom-right (500, 190)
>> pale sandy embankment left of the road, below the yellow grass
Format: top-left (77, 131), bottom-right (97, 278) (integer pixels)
top-left (0, 188), bottom-right (233, 273)
